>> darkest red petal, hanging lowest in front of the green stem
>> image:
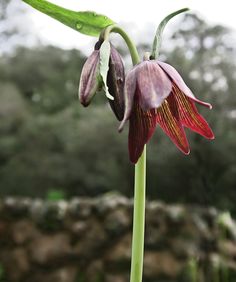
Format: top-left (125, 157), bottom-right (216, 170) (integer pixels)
top-left (129, 102), bottom-right (156, 164)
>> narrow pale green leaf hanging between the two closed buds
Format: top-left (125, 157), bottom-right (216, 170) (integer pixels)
top-left (100, 40), bottom-right (114, 100)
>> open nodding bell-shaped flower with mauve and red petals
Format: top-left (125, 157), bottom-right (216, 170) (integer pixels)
top-left (119, 60), bottom-right (214, 163)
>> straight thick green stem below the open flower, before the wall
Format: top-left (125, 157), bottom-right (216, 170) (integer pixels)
top-left (130, 145), bottom-right (146, 282)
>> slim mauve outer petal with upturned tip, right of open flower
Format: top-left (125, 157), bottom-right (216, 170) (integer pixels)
top-left (157, 61), bottom-right (212, 109)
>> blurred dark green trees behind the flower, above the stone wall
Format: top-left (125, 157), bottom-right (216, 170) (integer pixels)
top-left (0, 0), bottom-right (236, 282)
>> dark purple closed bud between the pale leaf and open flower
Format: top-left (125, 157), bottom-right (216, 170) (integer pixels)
top-left (107, 46), bottom-right (125, 121)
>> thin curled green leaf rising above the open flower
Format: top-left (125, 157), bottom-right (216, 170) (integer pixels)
top-left (151, 8), bottom-right (189, 59)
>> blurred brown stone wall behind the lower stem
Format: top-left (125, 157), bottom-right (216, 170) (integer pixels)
top-left (0, 194), bottom-right (236, 282)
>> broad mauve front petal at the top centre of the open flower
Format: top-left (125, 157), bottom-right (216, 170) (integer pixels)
top-left (137, 61), bottom-right (172, 111)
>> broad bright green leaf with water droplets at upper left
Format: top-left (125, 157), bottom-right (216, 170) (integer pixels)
top-left (23, 0), bottom-right (114, 37)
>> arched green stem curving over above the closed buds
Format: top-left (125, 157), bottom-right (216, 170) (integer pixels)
top-left (103, 25), bottom-right (140, 65)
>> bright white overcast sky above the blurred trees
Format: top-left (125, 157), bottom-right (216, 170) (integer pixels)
top-left (22, 0), bottom-right (236, 53)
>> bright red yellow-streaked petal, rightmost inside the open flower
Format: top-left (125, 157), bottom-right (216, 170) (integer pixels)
top-left (173, 86), bottom-right (214, 139)
